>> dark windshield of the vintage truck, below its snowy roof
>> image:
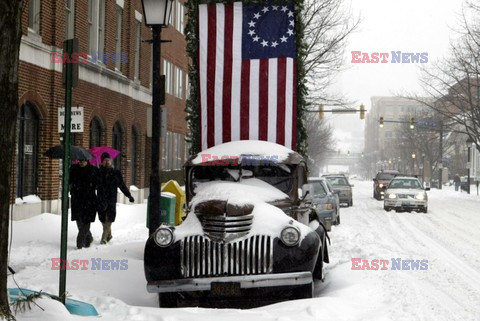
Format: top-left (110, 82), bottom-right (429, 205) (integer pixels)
top-left (191, 166), bottom-right (293, 194)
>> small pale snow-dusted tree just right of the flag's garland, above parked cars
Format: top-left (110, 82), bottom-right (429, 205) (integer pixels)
top-left (307, 113), bottom-right (335, 176)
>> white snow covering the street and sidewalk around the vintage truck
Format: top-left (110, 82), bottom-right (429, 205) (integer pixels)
top-left (9, 181), bottom-right (480, 321)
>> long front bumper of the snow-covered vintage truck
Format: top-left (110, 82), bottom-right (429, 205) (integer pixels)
top-left (147, 272), bottom-right (313, 293)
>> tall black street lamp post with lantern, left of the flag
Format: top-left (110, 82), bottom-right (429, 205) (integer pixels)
top-left (142, 0), bottom-right (173, 234)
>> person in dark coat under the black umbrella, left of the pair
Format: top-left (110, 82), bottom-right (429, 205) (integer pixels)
top-left (70, 159), bottom-right (98, 249)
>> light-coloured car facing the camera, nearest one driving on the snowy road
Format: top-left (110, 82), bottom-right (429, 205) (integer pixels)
top-left (383, 176), bottom-right (430, 213)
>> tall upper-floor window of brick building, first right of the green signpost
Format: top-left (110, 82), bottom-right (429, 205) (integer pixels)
top-left (88, 0), bottom-right (105, 56)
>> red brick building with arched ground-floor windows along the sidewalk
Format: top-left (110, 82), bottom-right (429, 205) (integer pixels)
top-left (12, 0), bottom-right (188, 219)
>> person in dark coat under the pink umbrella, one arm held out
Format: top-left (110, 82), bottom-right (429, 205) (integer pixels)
top-left (97, 153), bottom-right (135, 244)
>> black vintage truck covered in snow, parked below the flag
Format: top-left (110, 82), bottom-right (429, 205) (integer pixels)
top-left (144, 141), bottom-right (328, 307)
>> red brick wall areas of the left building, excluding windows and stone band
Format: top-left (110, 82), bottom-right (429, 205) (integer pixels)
top-left (12, 0), bottom-right (188, 200)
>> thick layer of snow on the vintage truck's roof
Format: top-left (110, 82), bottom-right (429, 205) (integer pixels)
top-left (190, 140), bottom-right (302, 165)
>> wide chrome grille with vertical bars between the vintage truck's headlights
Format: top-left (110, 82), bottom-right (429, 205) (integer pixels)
top-left (180, 235), bottom-right (273, 277)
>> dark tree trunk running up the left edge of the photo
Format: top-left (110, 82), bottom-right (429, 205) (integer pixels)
top-left (0, 0), bottom-right (22, 319)
